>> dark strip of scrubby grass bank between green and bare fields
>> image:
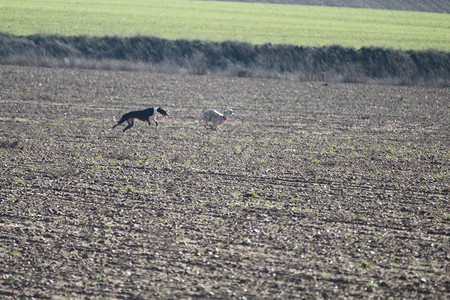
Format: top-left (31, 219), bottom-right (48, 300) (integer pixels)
top-left (0, 34), bottom-right (450, 86)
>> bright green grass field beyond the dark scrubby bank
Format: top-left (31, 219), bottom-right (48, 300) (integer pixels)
top-left (0, 0), bottom-right (450, 51)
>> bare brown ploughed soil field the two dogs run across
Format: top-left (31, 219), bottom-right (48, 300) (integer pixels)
top-left (0, 66), bottom-right (450, 299)
